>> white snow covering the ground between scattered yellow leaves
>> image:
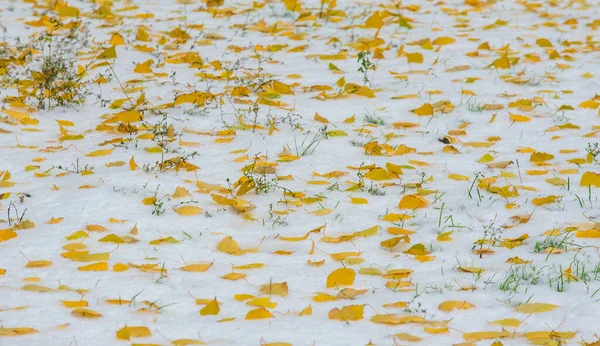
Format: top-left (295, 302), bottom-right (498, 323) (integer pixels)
top-left (0, 0), bottom-right (600, 346)
